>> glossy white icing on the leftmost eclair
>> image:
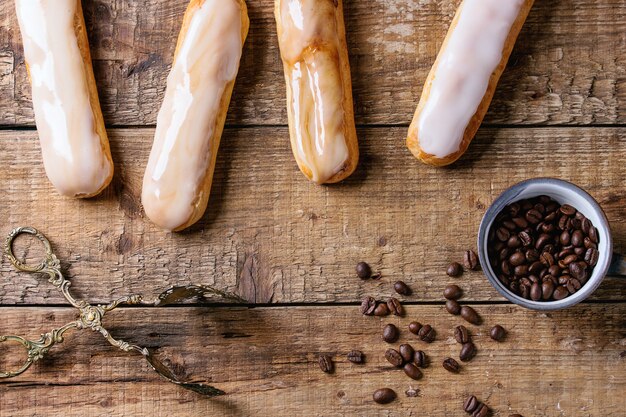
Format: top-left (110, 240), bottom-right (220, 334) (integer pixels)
top-left (15, 0), bottom-right (113, 196)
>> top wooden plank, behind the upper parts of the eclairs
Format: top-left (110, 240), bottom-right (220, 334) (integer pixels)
top-left (0, 0), bottom-right (626, 125)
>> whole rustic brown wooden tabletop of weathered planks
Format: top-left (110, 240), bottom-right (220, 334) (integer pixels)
top-left (0, 0), bottom-right (626, 417)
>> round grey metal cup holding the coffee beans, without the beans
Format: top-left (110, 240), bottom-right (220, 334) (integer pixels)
top-left (478, 178), bottom-right (626, 310)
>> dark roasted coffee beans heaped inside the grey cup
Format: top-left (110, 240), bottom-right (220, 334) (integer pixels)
top-left (488, 196), bottom-right (599, 301)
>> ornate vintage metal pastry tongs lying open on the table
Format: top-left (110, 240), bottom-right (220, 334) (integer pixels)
top-left (0, 227), bottom-right (246, 397)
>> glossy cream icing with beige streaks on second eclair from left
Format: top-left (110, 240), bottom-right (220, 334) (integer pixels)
top-left (142, 0), bottom-right (247, 230)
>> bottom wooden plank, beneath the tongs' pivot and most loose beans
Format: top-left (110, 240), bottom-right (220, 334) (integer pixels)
top-left (0, 303), bottom-right (626, 417)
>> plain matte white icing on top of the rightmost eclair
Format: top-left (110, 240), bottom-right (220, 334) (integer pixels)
top-left (417, 0), bottom-right (524, 158)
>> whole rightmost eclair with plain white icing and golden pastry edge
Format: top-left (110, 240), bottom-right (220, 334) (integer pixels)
top-left (407, 0), bottom-right (534, 166)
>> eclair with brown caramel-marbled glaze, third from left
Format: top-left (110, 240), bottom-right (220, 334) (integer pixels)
top-left (274, 0), bottom-right (359, 184)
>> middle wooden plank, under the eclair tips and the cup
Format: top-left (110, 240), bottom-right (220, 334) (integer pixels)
top-left (0, 127), bottom-right (626, 304)
